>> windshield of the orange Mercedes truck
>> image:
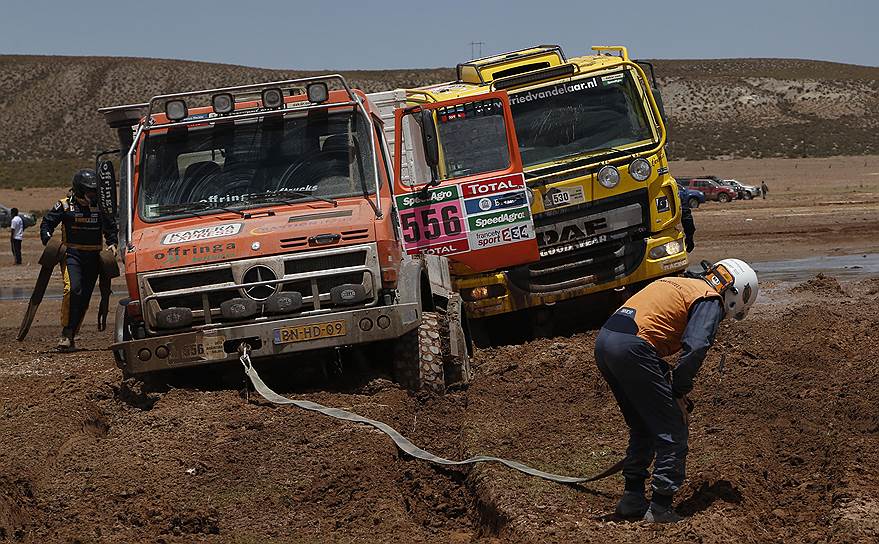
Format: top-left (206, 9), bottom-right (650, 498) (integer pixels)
top-left (139, 110), bottom-right (375, 221)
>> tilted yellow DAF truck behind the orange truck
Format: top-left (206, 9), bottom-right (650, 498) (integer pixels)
top-left (370, 45), bottom-right (687, 343)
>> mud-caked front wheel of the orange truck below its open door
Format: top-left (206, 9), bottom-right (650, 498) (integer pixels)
top-left (393, 312), bottom-right (446, 393)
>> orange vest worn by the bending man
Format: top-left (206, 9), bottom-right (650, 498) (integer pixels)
top-left (621, 277), bottom-right (721, 357)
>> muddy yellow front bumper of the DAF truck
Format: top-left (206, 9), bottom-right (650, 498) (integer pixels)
top-left (455, 228), bottom-right (688, 318)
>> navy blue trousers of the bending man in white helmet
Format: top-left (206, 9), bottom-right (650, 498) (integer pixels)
top-left (595, 329), bottom-right (688, 495)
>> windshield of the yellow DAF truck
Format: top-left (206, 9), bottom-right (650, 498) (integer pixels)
top-left (510, 71), bottom-right (653, 167)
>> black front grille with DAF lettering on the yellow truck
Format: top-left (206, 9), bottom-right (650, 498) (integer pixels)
top-left (509, 189), bottom-right (649, 293)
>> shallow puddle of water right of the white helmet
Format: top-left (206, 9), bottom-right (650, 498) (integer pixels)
top-left (692, 253), bottom-right (879, 281)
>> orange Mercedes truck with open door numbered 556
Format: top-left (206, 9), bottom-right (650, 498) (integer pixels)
top-left (99, 75), bottom-right (538, 391)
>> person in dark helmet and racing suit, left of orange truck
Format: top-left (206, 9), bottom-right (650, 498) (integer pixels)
top-left (40, 169), bottom-right (116, 351)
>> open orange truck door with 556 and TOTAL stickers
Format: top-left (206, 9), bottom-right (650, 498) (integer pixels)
top-left (394, 91), bottom-right (539, 272)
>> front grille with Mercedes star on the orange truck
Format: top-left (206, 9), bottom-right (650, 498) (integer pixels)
top-left (140, 244), bottom-right (381, 329)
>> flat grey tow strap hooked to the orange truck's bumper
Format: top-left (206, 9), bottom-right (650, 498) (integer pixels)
top-left (239, 344), bottom-right (625, 484)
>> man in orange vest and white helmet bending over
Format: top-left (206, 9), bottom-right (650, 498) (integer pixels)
top-left (595, 259), bottom-right (757, 523)
